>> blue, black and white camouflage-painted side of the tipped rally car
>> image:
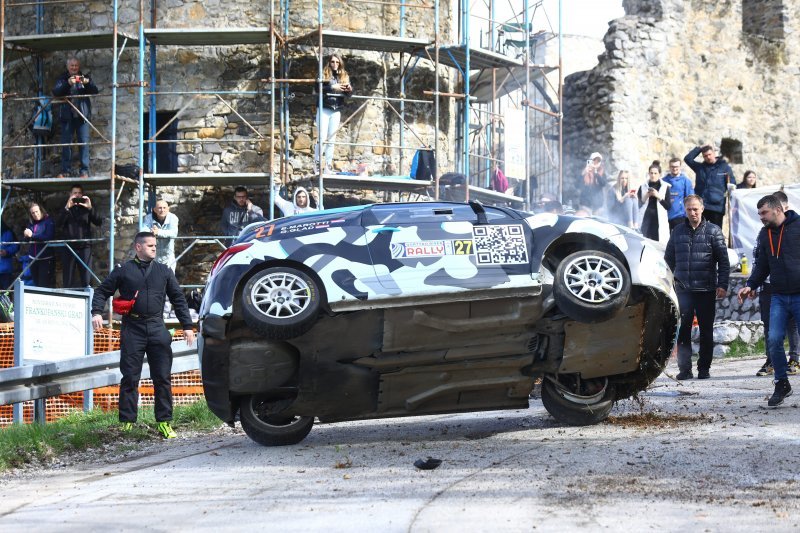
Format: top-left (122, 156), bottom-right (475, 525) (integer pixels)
top-left (201, 202), bottom-right (674, 317)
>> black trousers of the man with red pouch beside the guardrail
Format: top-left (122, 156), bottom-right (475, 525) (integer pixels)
top-left (119, 316), bottom-right (172, 422)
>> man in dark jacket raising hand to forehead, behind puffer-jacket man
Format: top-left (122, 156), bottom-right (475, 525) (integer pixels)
top-left (683, 144), bottom-right (736, 228)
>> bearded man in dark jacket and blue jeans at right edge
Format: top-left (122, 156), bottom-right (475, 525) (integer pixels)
top-left (739, 195), bottom-right (800, 406)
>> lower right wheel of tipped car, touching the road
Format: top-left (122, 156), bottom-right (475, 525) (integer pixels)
top-left (542, 376), bottom-right (616, 426)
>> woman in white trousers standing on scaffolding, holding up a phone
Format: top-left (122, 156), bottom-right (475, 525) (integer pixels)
top-left (314, 54), bottom-right (353, 170)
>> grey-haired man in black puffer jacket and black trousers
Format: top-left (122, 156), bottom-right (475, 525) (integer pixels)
top-left (664, 194), bottom-right (730, 379)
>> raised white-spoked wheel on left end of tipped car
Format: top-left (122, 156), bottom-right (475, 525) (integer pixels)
top-left (242, 267), bottom-right (320, 340)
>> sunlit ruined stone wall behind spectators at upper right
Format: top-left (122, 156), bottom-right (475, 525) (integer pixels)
top-left (564, 0), bottom-right (800, 200)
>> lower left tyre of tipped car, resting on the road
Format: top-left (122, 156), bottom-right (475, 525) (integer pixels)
top-left (239, 395), bottom-right (314, 446)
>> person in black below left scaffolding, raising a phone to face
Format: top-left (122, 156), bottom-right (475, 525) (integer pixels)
top-left (56, 183), bottom-right (103, 289)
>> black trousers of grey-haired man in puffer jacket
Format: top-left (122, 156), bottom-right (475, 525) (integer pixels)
top-left (677, 291), bottom-right (716, 372)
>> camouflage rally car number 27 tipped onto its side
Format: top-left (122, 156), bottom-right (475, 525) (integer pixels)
top-left (198, 202), bottom-right (678, 446)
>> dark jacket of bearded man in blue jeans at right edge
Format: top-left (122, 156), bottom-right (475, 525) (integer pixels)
top-left (747, 210), bottom-right (800, 294)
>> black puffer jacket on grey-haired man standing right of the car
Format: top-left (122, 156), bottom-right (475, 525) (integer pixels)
top-left (664, 220), bottom-right (731, 291)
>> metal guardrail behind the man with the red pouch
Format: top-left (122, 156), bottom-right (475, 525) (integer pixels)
top-left (0, 341), bottom-right (200, 405)
